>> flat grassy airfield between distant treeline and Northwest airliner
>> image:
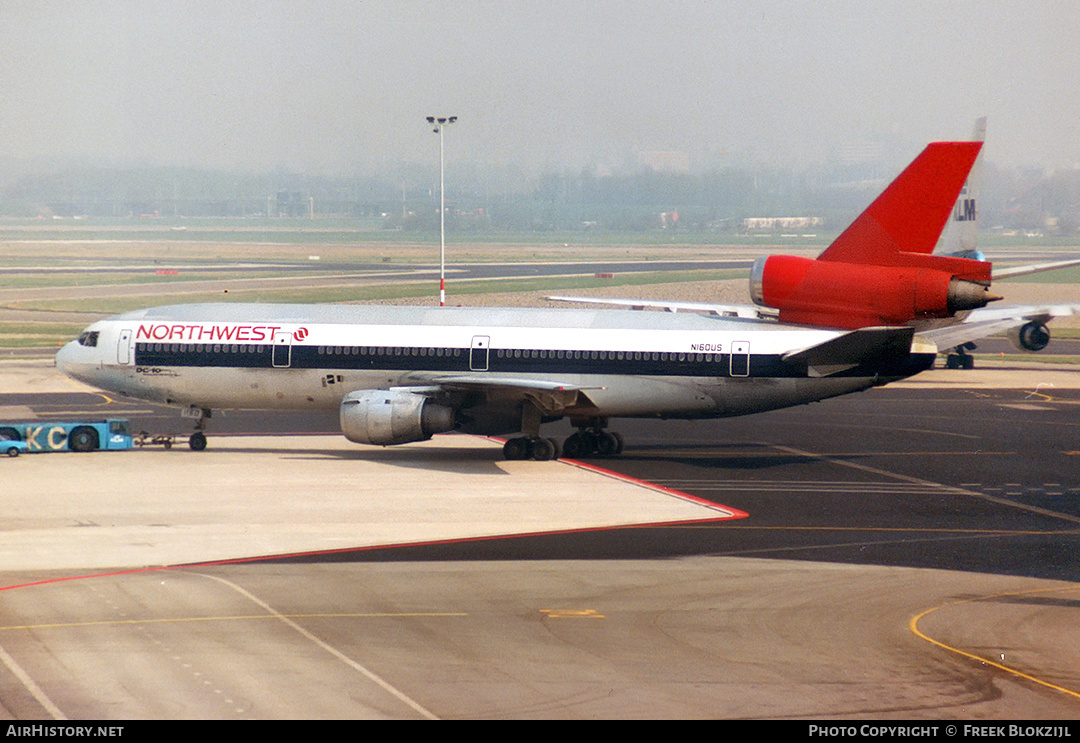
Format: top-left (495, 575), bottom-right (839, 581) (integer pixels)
top-left (0, 220), bottom-right (1080, 360)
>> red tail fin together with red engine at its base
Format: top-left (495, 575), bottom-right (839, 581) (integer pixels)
top-left (751, 141), bottom-right (999, 328)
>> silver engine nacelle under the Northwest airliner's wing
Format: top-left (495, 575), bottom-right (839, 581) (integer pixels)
top-left (340, 390), bottom-right (456, 446)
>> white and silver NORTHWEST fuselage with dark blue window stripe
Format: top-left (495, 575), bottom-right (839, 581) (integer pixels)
top-left (56, 305), bottom-right (926, 433)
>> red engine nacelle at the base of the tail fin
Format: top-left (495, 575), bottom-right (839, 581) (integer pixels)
top-left (750, 256), bottom-right (998, 328)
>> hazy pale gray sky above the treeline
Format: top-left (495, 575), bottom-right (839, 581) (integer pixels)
top-left (0, 0), bottom-right (1080, 173)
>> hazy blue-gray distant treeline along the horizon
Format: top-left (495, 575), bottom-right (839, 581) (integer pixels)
top-left (0, 164), bottom-right (1080, 234)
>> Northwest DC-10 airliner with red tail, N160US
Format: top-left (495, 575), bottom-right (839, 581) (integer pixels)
top-left (56, 141), bottom-right (1080, 460)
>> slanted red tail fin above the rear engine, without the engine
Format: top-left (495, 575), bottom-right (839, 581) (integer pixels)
top-left (818, 141), bottom-right (983, 266)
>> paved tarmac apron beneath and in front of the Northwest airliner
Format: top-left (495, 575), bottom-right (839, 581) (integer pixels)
top-left (0, 362), bottom-right (1080, 719)
